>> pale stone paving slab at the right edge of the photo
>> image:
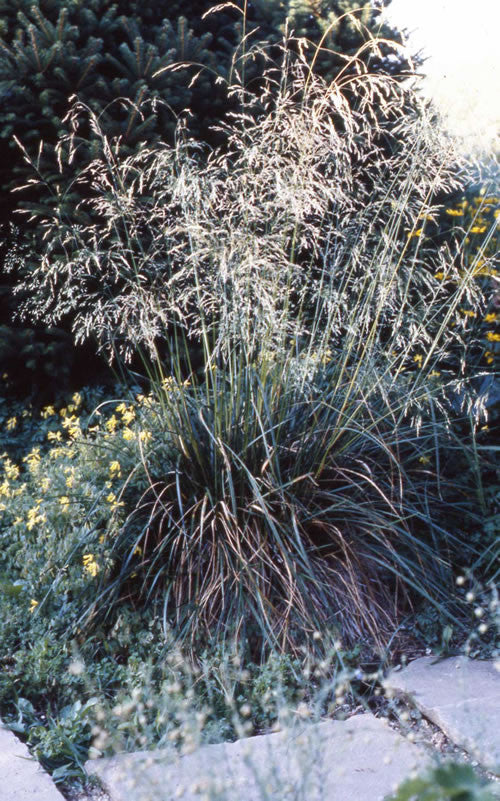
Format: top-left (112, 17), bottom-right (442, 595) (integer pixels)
top-left (384, 656), bottom-right (500, 775)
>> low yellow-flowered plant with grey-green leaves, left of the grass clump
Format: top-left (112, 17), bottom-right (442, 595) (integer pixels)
top-left (0, 382), bottom-right (168, 628)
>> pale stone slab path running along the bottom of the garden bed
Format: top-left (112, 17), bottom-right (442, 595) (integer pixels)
top-left (0, 657), bottom-right (500, 801)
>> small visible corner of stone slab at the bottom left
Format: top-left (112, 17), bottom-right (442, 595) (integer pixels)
top-left (0, 721), bottom-right (64, 801)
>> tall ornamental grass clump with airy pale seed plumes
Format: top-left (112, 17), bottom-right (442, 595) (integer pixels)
top-left (1, 43), bottom-right (490, 650)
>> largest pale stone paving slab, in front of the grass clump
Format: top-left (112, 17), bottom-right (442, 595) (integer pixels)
top-left (85, 713), bottom-right (429, 801)
